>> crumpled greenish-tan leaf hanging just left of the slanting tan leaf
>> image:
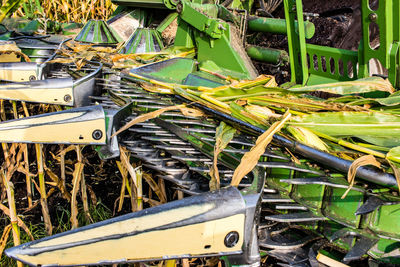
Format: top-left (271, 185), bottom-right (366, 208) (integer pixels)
top-left (210, 121), bottom-right (236, 191)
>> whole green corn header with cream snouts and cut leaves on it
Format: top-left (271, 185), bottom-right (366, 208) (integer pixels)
top-left (0, 0), bottom-right (400, 266)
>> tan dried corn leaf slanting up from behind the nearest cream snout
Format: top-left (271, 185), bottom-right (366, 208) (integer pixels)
top-left (231, 111), bottom-right (290, 186)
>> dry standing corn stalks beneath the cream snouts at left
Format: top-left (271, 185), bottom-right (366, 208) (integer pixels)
top-left (0, 100), bottom-right (168, 263)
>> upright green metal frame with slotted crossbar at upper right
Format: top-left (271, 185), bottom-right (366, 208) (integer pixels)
top-left (283, 0), bottom-right (400, 88)
